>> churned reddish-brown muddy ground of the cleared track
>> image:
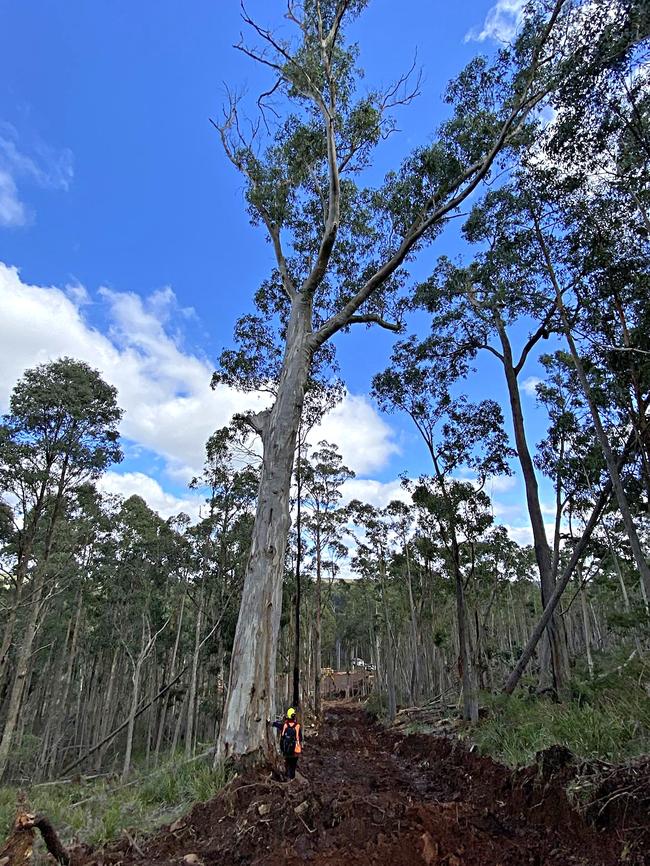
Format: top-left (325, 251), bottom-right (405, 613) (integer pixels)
top-left (74, 704), bottom-right (650, 866)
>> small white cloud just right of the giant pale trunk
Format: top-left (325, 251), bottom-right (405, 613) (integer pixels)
top-left (310, 392), bottom-right (399, 474)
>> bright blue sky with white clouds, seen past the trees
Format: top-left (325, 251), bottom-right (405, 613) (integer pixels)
top-left (0, 0), bottom-right (556, 539)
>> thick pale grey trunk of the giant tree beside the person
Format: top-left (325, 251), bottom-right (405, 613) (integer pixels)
top-left (215, 296), bottom-right (311, 761)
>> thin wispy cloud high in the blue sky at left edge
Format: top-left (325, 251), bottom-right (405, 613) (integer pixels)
top-left (0, 122), bottom-right (74, 227)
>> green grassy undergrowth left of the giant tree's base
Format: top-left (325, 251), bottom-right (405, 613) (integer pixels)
top-left (0, 759), bottom-right (228, 863)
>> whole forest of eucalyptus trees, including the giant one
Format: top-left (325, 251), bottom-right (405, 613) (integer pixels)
top-left (0, 0), bottom-right (650, 780)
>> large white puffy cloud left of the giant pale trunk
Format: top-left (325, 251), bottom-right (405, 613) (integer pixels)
top-left (0, 263), bottom-right (270, 478)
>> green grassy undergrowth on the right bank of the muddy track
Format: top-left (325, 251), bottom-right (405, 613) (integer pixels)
top-left (466, 660), bottom-right (650, 766)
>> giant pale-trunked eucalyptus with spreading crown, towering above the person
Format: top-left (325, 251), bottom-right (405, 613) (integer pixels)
top-left (215, 0), bottom-right (588, 761)
